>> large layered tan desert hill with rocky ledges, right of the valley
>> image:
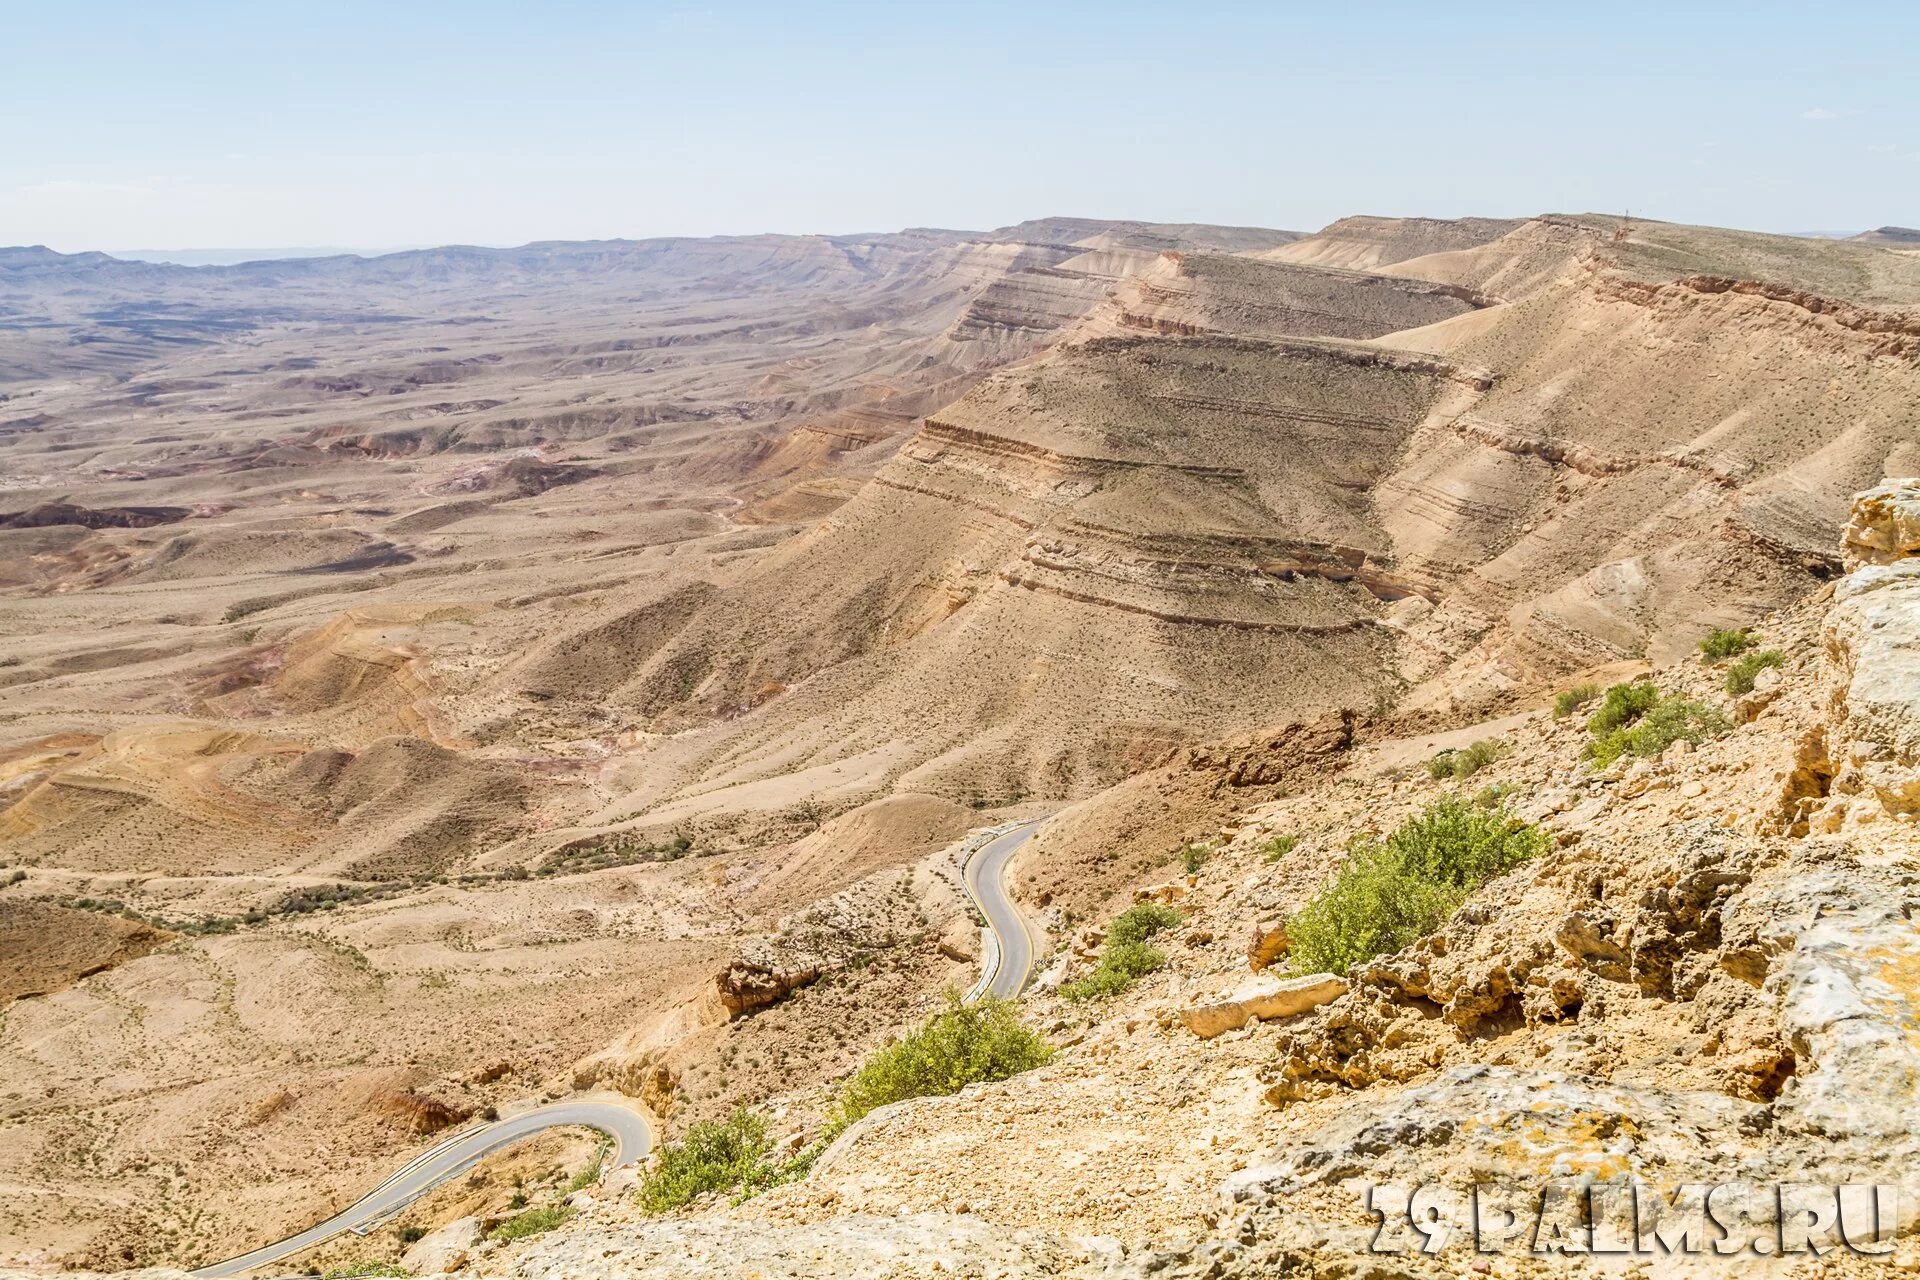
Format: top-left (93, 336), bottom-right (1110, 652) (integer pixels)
top-left (499, 219), bottom-right (1920, 840)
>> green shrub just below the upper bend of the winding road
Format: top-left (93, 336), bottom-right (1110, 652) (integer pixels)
top-left (835, 992), bottom-right (1054, 1126)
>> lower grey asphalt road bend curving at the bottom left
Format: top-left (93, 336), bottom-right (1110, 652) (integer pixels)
top-left (192, 1102), bottom-right (653, 1276)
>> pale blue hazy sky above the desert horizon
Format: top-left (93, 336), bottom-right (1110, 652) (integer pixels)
top-left (0, 0), bottom-right (1920, 251)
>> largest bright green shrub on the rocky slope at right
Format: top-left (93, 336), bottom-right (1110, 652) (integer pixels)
top-left (1286, 796), bottom-right (1546, 973)
